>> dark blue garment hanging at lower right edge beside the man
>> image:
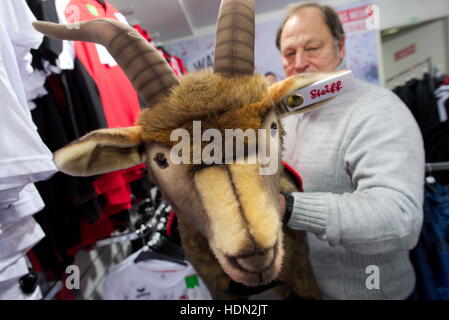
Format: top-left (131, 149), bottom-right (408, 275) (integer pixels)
top-left (410, 183), bottom-right (449, 300)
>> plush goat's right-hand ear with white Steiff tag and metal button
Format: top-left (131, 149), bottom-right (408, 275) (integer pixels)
top-left (268, 70), bottom-right (354, 117)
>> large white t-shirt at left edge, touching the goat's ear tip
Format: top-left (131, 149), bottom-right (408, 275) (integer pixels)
top-left (0, 23), bottom-right (57, 191)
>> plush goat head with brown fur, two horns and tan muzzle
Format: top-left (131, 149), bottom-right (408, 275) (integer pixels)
top-left (34, 0), bottom-right (344, 285)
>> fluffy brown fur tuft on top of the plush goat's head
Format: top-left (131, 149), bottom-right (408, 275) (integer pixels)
top-left (137, 70), bottom-right (273, 146)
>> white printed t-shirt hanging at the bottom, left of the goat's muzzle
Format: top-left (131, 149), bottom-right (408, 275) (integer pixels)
top-left (103, 250), bottom-right (212, 300)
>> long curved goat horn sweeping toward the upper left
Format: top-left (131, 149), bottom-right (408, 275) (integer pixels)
top-left (33, 18), bottom-right (178, 106)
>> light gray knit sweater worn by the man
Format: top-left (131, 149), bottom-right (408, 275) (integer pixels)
top-left (283, 80), bottom-right (425, 299)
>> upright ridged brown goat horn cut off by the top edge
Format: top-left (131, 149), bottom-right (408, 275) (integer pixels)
top-left (214, 0), bottom-right (254, 76)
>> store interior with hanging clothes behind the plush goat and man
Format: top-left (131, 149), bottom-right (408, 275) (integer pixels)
top-left (0, 0), bottom-right (449, 300)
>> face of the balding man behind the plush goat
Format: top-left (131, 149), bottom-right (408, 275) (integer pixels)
top-left (280, 7), bottom-right (344, 76)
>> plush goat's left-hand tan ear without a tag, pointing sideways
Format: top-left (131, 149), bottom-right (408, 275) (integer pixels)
top-left (53, 126), bottom-right (145, 177)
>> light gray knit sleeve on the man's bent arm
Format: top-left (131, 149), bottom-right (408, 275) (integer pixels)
top-left (288, 91), bottom-right (425, 254)
